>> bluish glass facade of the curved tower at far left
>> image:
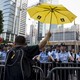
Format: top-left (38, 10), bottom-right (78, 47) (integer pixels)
top-left (3, 0), bottom-right (16, 33)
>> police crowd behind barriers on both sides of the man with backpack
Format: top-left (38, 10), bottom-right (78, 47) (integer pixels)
top-left (0, 43), bottom-right (80, 63)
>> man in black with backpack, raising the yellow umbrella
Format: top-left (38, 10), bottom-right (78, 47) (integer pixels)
top-left (4, 31), bottom-right (51, 80)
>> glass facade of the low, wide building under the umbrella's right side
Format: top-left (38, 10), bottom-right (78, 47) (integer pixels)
top-left (52, 31), bottom-right (79, 41)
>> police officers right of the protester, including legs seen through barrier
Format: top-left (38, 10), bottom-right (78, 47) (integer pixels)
top-left (33, 43), bottom-right (80, 80)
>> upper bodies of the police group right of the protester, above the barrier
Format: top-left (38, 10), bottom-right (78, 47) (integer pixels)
top-left (33, 43), bottom-right (80, 63)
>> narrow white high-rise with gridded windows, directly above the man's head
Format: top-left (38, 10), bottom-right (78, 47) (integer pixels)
top-left (18, 3), bottom-right (27, 36)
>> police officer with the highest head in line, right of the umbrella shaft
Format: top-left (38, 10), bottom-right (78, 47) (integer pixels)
top-left (58, 43), bottom-right (74, 80)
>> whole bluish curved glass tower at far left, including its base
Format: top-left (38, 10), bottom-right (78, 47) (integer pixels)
top-left (0, 0), bottom-right (16, 42)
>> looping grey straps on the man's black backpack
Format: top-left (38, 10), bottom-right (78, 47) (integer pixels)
top-left (3, 48), bottom-right (24, 80)
